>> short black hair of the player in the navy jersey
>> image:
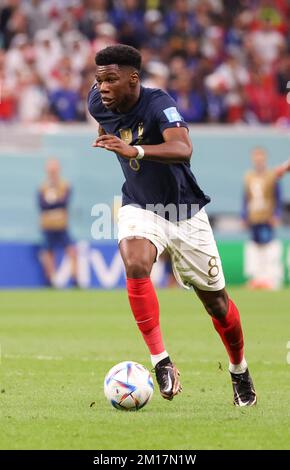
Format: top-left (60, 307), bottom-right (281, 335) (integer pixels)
top-left (95, 44), bottom-right (141, 70)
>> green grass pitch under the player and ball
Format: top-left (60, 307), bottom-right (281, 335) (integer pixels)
top-left (0, 289), bottom-right (290, 450)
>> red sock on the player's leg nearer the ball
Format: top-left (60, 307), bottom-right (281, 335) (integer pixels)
top-left (127, 277), bottom-right (165, 354)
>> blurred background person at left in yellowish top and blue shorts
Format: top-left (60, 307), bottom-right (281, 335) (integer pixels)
top-left (38, 159), bottom-right (77, 287)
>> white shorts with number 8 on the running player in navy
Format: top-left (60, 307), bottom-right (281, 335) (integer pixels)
top-left (118, 205), bottom-right (225, 291)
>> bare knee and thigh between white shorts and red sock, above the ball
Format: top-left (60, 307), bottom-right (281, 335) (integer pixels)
top-left (119, 237), bottom-right (157, 277)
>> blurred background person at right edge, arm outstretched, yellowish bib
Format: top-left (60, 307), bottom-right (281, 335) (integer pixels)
top-left (242, 148), bottom-right (290, 289)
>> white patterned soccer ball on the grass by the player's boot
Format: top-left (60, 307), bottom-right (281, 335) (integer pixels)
top-left (104, 361), bottom-right (154, 411)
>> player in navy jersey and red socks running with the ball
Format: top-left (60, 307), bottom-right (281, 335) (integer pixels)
top-left (88, 44), bottom-right (257, 406)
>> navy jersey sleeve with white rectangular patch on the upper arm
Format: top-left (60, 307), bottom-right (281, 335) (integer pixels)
top-left (152, 91), bottom-right (188, 133)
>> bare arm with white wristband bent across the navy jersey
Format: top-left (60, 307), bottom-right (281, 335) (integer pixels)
top-left (93, 127), bottom-right (192, 163)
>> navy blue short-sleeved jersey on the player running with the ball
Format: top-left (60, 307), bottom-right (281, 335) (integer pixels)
top-left (88, 86), bottom-right (210, 220)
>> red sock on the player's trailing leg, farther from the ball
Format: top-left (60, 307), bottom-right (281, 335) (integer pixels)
top-left (212, 299), bottom-right (244, 364)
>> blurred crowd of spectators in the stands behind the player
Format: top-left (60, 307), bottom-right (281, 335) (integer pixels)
top-left (0, 0), bottom-right (290, 126)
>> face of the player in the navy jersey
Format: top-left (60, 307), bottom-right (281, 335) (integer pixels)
top-left (96, 64), bottom-right (138, 111)
